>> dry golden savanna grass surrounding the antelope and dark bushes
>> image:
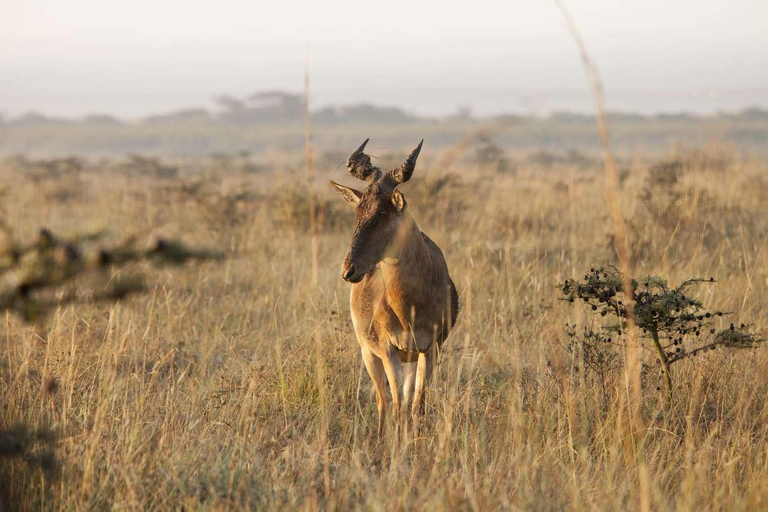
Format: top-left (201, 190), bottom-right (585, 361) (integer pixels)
top-left (0, 141), bottom-right (768, 510)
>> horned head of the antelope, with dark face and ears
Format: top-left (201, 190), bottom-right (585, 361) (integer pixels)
top-left (331, 139), bottom-right (424, 283)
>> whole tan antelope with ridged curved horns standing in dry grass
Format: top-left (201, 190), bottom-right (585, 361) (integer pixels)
top-left (331, 139), bottom-right (459, 438)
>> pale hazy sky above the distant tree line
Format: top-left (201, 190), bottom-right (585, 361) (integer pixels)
top-left (0, 0), bottom-right (768, 118)
